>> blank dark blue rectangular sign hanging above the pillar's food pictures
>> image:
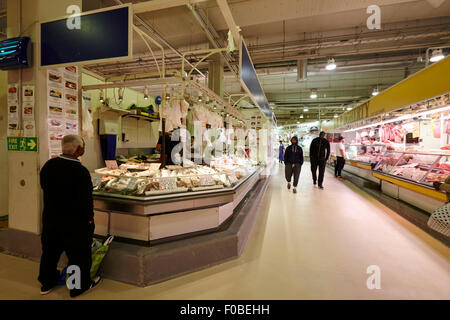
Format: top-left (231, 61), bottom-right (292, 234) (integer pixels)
top-left (41, 7), bottom-right (131, 66)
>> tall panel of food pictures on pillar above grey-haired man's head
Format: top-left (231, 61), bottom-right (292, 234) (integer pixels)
top-left (47, 66), bottom-right (79, 158)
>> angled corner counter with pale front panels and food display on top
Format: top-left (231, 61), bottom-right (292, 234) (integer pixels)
top-left (92, 160), bottom-right (264, 245)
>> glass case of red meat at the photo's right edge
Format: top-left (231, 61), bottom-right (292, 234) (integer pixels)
top-left (374, 151), bottom-right (450, 187)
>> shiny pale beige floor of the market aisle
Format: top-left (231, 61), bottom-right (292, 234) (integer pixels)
top-left (0, 164), bottom-right (450, 299)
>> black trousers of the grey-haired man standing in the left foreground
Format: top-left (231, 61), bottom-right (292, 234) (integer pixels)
top-left (38, 226), bottom-right (93, 291)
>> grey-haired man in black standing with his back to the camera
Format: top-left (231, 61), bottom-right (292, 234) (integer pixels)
top-left (38, 135), bottom-right (100, 297)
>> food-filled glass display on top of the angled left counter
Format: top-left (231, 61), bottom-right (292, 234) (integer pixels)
top-left (92, 160), bottom-right (256, 200)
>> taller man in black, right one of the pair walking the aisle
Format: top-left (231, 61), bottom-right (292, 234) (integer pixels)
top-left (309, 131), bottom-right (330, 189)
